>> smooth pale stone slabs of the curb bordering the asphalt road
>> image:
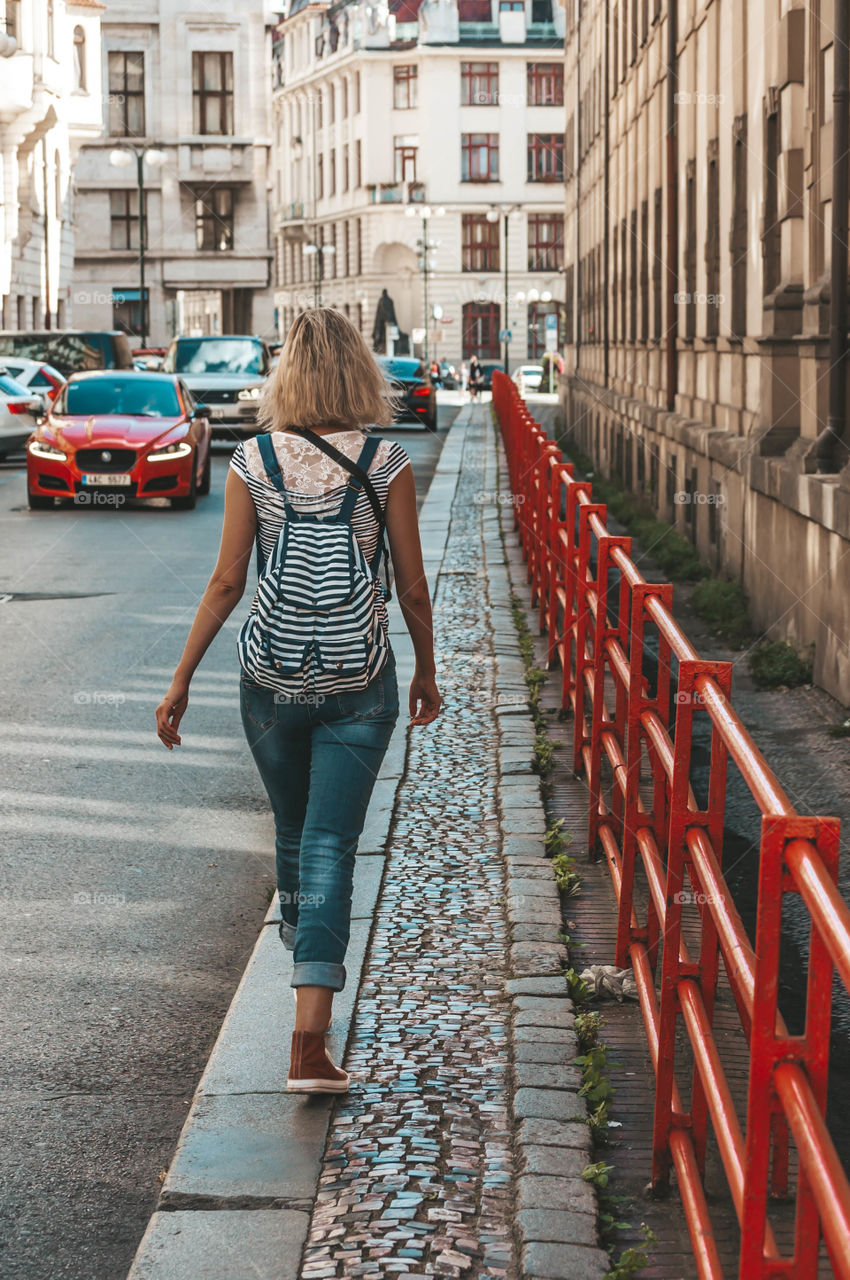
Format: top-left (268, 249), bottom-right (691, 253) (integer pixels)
top-left (128, 406), bottom-right (471, 1280)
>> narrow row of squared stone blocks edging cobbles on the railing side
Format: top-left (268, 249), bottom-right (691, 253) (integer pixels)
top-left (484, 412), bottom-right (611, 1280)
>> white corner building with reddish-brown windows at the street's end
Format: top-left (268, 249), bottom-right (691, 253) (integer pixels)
top-left (273, 0), bottom-right (565, 369)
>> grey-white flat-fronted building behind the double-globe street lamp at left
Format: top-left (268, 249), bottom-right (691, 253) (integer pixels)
top-left (73, 0), bottom-right (277, 346)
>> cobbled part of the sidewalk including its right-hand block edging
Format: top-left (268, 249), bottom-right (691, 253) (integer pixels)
top-left (301, 407), bottom-right (608, 1280)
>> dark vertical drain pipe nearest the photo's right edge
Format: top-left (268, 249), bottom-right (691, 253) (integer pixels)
top-left (815, 4), bottom-right (850, 474)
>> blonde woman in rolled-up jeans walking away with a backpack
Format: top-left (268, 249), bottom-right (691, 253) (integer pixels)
top-left (156, 307), bottom-right (440, 1093)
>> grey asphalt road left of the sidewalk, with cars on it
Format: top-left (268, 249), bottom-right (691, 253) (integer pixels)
top-left (0, 404), bottom-right (458, 1280)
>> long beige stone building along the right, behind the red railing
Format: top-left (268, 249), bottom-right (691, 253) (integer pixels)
top-left (561, 0), bottom-right (850, 701)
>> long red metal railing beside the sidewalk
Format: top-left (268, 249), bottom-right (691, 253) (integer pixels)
top-left (493, 372), bottom-right (850, 1280)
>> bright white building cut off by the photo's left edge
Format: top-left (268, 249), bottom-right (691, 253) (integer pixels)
top-left (0, 0), bottom-right (104, 330)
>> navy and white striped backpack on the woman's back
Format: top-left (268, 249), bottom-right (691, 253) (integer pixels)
top-left (237, 430), bottom-right (389, 701)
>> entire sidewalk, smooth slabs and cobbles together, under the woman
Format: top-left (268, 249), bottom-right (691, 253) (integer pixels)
top-left (129, 406), bottom-right (608, 1280)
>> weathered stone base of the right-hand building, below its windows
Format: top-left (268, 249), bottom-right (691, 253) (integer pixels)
top-left (558, 375), bottom-right (850, 704)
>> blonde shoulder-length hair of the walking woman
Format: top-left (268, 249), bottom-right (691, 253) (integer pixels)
top-left (259, 307), bottom-right (396, 431)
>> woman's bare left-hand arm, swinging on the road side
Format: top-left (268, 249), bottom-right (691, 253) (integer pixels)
top-left (156, 470), bottom-right (257, 751)
